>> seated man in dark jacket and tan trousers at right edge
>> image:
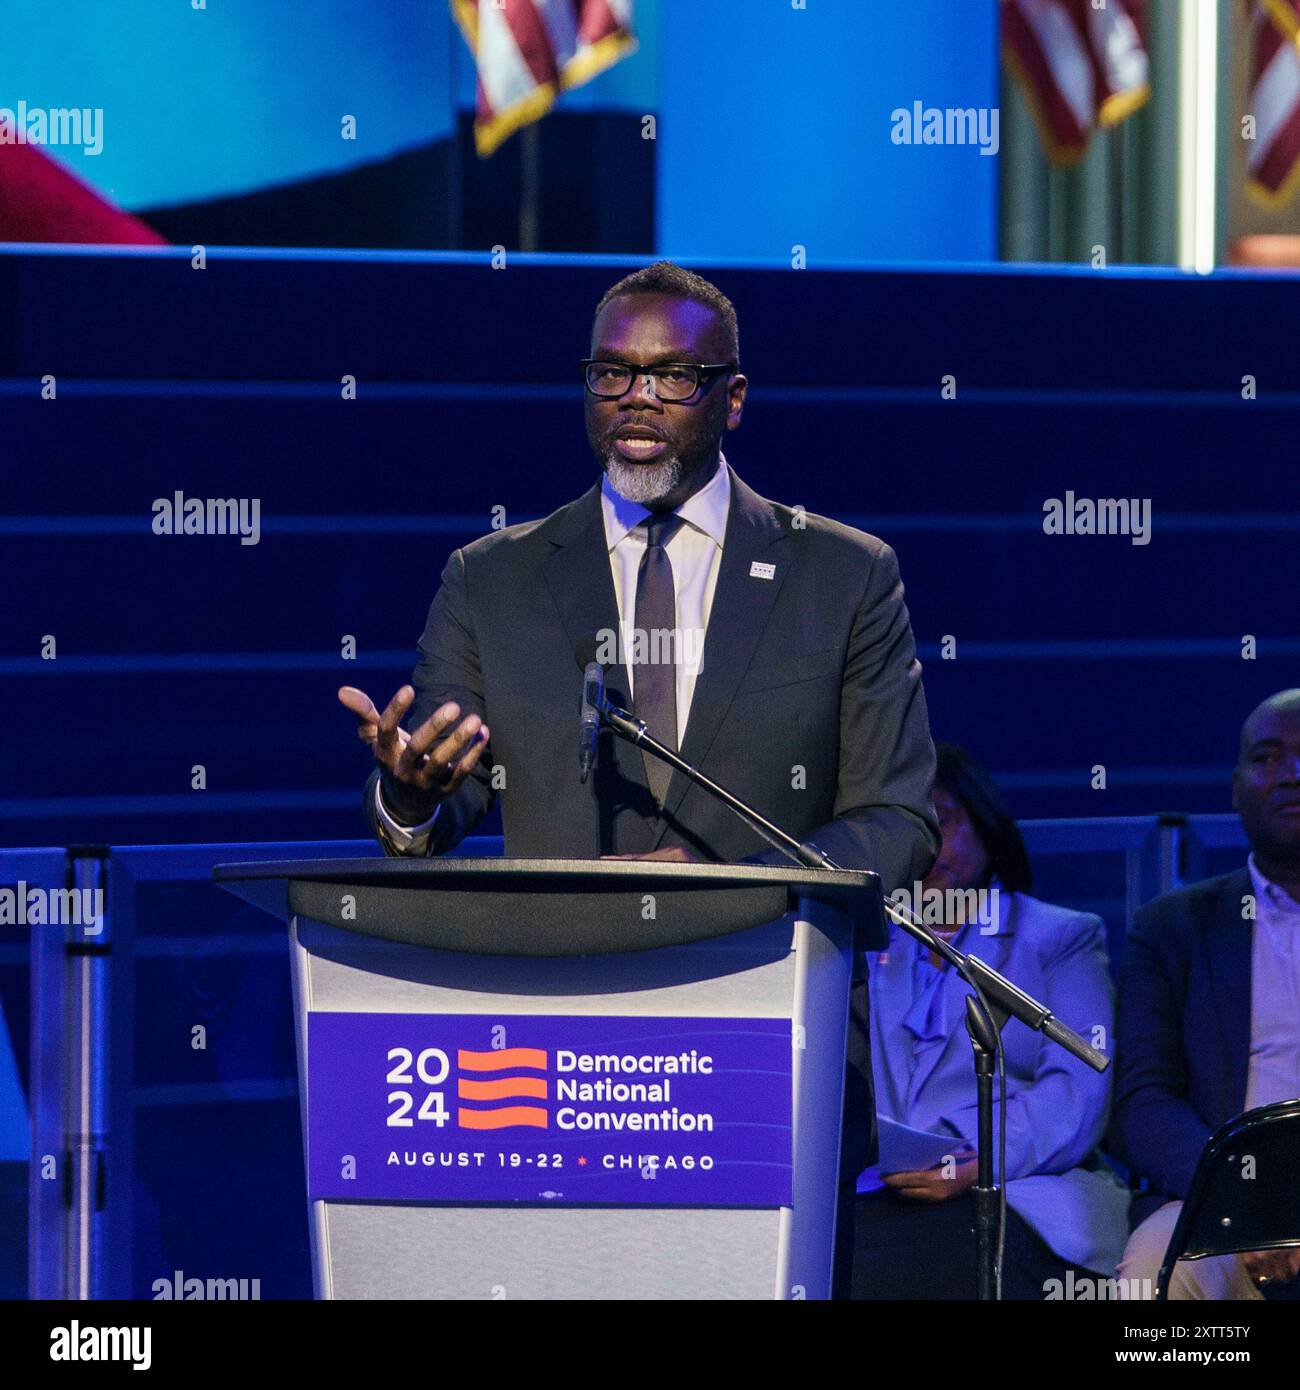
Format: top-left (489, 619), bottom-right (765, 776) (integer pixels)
top-left (1111, 689), bottom-right (1300, 1298)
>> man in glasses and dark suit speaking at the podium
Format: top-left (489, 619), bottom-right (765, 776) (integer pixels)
top-left (339, 261), bottom-right (939, 1289)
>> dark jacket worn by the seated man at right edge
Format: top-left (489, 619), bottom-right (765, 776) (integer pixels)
top-left (1111, 869), bottom-right (1254, 1226)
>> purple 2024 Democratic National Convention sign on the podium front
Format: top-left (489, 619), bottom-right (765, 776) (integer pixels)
top-left (307, 1013), bottom-right (793, 1207)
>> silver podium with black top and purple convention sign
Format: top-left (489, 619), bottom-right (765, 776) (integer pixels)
top-left (213, 859), bottom-right (886, 1298)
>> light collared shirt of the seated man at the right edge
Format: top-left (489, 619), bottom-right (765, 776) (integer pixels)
top-left (1246, 855), bottom-right (1300, 1111)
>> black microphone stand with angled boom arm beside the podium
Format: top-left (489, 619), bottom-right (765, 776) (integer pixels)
top-left (596, 692), bottom-right (1111, 1300)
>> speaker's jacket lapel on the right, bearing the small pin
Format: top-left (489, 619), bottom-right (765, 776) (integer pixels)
top-left (656, 466), bottom-right (788, 845)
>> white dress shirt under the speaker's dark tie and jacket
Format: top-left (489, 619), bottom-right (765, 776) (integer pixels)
top-left (375, 452), bottom-right (731, 855)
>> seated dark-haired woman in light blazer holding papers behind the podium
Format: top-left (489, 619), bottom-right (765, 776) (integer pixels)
top-left (854, 744), bottom-right (1129, 1298)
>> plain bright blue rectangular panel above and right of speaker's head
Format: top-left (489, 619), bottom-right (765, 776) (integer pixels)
top-left (656, 0), bottom-right (998, 265)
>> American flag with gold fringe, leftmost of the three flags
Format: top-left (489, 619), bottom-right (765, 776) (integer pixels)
top-left (450, 0), bottom-right (637, 157)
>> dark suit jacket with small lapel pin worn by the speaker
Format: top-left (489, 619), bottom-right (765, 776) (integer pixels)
top-left (366, 471), bottom-right (939, 891)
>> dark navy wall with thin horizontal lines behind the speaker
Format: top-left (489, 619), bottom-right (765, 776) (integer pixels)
top-left (0, 249), bottom-right (1300, 845)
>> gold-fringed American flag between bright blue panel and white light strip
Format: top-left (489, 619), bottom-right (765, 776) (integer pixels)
top-left (1002, 0), bottom-right (1151, 164)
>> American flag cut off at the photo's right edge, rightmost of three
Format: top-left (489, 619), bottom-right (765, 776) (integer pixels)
top-left (1246, 0), bottom-right (1300, 207)
